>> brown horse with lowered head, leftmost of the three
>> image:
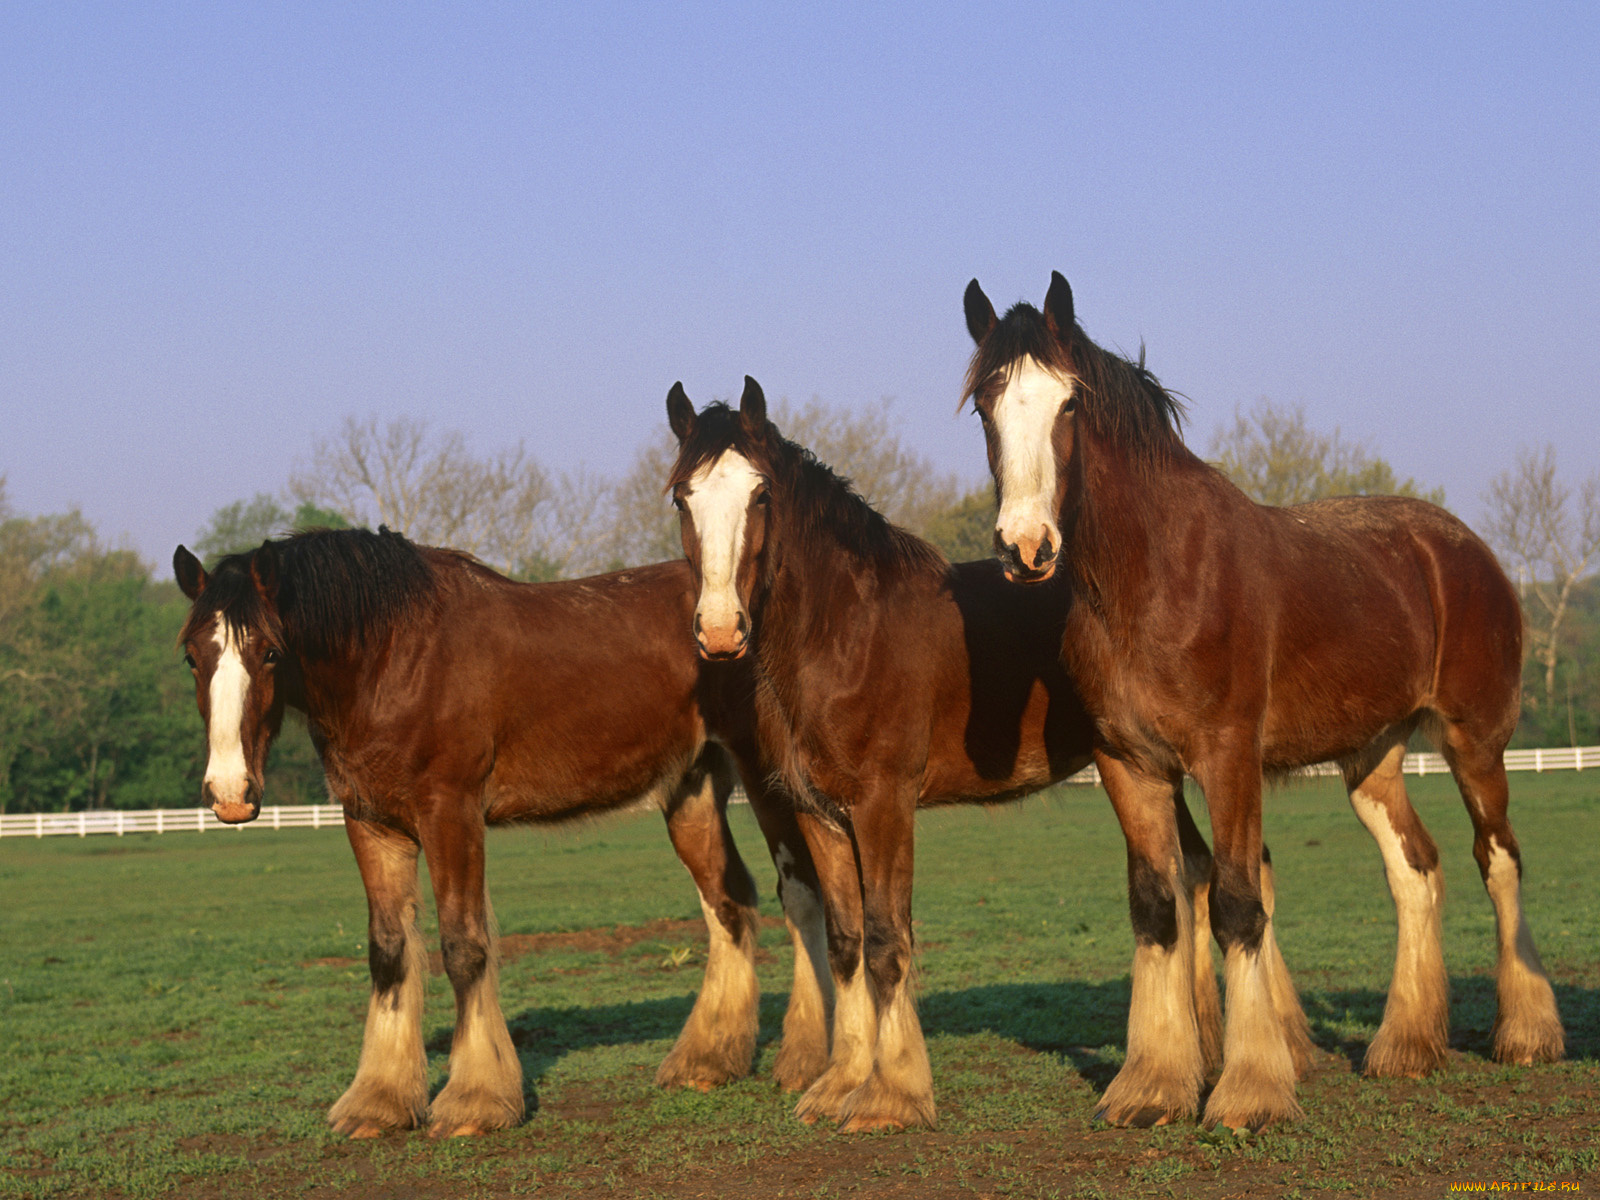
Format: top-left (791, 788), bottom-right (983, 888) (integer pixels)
top-left (173, 530), bottom-right (830, 1138)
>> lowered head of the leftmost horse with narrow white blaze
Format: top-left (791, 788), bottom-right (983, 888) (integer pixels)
top-left (173, 542), bottom-right (293, 824)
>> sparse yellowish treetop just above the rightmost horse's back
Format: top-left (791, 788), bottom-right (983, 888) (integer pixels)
top-left (1210, 398), bottom-right (1445, 506)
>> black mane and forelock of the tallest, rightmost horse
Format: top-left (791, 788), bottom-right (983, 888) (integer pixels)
top-left (962, 304), bottom-right (1184, 458)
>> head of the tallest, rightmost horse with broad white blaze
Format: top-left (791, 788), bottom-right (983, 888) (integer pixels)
top-left (965, 272), bottom-right (1078, 582)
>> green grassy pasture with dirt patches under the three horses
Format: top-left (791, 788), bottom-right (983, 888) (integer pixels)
top-left (0, 773), bottom-right (1600, 1200)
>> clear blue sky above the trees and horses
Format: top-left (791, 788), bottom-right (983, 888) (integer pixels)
top-left (0, 0), bottom-right (1600, 570)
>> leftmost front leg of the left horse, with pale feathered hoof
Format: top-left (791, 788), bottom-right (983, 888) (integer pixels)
top-left (328, 818), bottom-right (427, 1138)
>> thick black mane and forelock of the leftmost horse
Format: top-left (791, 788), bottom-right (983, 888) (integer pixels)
top-left (182, 530), bottom-right (435, 658)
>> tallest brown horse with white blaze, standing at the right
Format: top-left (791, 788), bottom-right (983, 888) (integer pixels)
top-left (965, 274), bottom-right (1563, 1126)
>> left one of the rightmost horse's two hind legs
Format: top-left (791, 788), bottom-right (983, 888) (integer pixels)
top-left (1342, 741), bottom-right (1450, 1078)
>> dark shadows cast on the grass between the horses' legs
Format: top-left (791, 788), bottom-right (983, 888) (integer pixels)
top-left (441, 976), bottom-right (1600, 1112)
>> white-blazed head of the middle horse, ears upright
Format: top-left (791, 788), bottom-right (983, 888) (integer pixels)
top-left (667, 376), bottom-right (773, 659)
